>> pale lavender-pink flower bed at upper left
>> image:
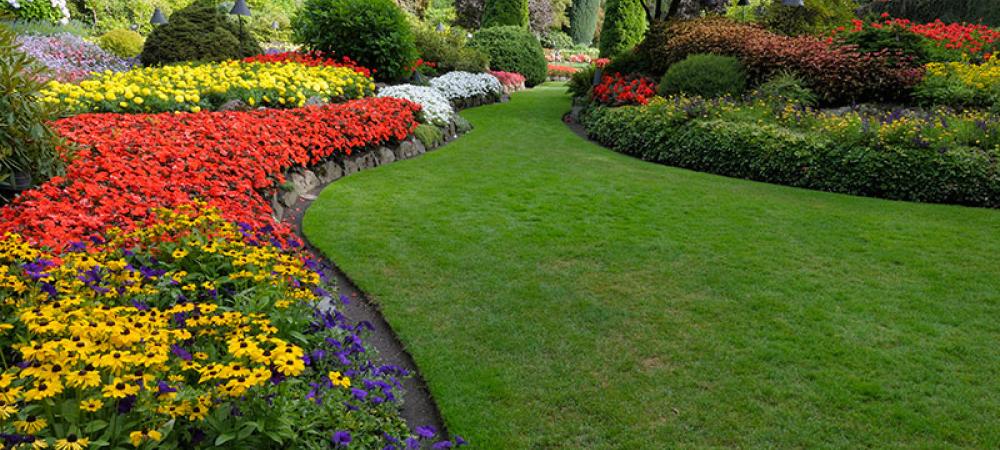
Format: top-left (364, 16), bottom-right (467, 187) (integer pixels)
top-left (17, 33), bottom-right (132, 83)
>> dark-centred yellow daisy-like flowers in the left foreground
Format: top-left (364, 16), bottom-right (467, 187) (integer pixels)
top-left (0, 202), bottom-right (382, 448)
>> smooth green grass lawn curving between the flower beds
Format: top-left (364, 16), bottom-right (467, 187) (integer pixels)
top-left (305, 87), bottom-right (1000, 449)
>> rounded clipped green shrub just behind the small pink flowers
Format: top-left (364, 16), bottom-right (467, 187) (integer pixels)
top-left (469, 26), bottom-right (548, 86)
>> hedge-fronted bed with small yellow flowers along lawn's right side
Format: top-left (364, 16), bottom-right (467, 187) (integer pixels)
top-left (583, 98), bottom-right (1000, 208)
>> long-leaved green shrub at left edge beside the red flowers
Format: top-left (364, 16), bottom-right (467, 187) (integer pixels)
top-left (0, 26), bottom-right (62, 188)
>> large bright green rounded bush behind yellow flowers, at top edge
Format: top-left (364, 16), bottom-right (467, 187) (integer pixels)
top-left (293, 0), bottom-right (417, 81)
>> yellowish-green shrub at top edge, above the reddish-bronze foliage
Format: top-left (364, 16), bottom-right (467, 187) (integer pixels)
top-left (761, 0), bottom-right (858, 36)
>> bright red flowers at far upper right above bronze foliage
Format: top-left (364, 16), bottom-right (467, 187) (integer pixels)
top-left (832, 14), bottom-right (1000, 59)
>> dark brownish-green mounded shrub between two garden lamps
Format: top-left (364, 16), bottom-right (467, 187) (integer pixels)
top-left (139, 0), bottom-right (262, 66)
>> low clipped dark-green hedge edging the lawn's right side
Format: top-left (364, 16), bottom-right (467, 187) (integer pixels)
top-left (582, 100), bottom-right (1000, 208)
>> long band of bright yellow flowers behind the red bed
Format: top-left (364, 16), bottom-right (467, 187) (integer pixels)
top-left (42, 61), bottom-right (375, 113)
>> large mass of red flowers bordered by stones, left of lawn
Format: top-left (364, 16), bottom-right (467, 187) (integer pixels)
top-left (0, 98), bottom-right (420, 249)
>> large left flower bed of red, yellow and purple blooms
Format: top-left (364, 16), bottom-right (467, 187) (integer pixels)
top-left (0, 90), bottom-right (474, 449)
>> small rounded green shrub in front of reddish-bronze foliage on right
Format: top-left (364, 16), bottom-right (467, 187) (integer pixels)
top-left (659, 54), bottom-right (747, 98)
